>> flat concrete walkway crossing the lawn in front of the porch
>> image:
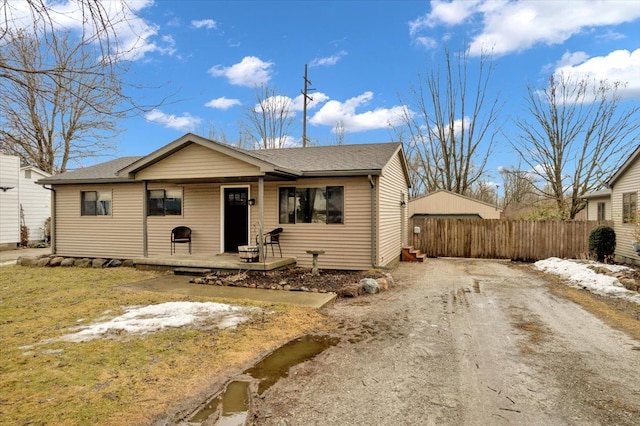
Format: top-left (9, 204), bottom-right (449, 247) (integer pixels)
top-left (122, 275), bottom-right (336, 309)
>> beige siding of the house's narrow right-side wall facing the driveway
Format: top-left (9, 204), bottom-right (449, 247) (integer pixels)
top-left (377, 154), bottom-right (407, 266)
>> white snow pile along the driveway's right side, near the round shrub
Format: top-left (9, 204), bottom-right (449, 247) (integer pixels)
top-left (534, 257), bottom-right (640, 304)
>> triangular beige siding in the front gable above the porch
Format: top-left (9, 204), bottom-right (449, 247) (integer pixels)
top-left (136, 144), bottom-right (261, 180)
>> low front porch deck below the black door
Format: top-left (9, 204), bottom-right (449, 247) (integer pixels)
top-left (133, 253), bottom-right (296, 272)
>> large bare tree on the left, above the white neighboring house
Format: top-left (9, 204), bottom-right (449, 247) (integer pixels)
top-left (0, 31), bottom-right (123, 173)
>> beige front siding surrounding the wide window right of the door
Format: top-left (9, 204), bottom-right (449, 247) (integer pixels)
top-left (258, 176), bottom-right (371, 270)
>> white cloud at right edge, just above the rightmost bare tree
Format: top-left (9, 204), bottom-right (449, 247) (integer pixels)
top-left (555, 48), bottom-right (640, 99)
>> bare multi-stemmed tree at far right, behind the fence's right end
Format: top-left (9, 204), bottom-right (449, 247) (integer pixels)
top-left (512, 75), bottom-right (640, 219)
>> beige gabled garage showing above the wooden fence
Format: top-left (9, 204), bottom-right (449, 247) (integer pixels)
top-left (409, 189), bottom-right (502, 219)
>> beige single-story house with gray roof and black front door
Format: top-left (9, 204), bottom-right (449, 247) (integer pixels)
top-left (39, 134), bottom-right (410, 270)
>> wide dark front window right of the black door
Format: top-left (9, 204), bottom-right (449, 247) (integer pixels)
top-left (279, 186), bottom-right (344, 224)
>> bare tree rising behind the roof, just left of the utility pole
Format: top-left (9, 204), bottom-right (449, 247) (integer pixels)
top-left (245, 85), bottom-right (294, 149)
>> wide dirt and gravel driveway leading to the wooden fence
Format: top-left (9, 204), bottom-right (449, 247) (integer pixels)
top-left (253, 259), bottom-right (640, 425)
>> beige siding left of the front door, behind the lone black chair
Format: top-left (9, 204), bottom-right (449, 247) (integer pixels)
top-left (147, 183), bottom-right (220, 257)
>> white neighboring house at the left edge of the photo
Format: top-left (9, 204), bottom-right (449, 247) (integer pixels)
top-left (0, 154), bottom-right (51, 248)
